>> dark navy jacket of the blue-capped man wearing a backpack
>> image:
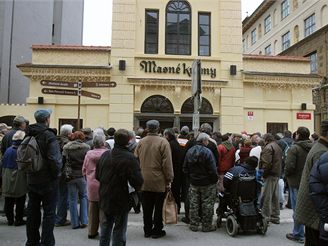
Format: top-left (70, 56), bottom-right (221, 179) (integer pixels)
top-left (27, 123), bottom-right (62, 184)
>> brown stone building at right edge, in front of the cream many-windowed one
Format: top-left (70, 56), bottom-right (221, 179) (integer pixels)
top-left (280, 24), bottom-right (328, 131)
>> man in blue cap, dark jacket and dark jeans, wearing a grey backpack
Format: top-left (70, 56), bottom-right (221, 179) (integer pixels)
top-left (26, 109), bottom-right (62, 246)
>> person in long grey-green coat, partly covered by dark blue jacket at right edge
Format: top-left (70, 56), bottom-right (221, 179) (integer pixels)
top-left (296, 120), bottom-right (328, 246)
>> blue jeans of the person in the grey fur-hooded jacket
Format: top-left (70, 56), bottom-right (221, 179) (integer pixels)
top-left (67, 177), bottom-right (88, 229)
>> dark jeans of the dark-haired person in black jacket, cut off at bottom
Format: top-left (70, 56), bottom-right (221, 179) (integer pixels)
top-left (99, 213), bottom-right (128, 246)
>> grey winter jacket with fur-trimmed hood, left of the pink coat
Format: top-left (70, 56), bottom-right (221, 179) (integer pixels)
top-left (63, 140), bottom-right (90, 178)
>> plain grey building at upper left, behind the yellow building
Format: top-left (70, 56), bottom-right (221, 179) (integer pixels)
top-left (0, 0), bottom-right (84, 103)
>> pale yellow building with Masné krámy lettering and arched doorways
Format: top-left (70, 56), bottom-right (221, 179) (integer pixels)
top-left (0, 0), bottom-right (321, 133)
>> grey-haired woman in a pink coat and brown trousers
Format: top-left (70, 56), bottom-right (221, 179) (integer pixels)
top-left (82, 131), bottom-right (108, 239)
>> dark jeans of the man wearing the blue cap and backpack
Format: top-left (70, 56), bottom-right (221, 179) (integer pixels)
top-left (26, 180), bottom-right (58, 246)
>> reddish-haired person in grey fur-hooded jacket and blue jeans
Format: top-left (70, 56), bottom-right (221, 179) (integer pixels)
top-left (63, 131), bottom-right (90, 229)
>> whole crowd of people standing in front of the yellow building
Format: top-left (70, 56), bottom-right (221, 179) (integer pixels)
top-left (0, 109), bottom-right (328, 246)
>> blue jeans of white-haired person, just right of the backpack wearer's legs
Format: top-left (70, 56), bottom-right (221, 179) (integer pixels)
top-left (55, 179), bottom-right (68, 225)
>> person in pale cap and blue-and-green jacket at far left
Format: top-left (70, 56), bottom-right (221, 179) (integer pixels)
top-left (2, 130), bottom-right (27, 226)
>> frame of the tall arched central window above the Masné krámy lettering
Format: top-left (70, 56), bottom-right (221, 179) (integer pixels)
top-left (165, 0), bottom-right (192, 56)
